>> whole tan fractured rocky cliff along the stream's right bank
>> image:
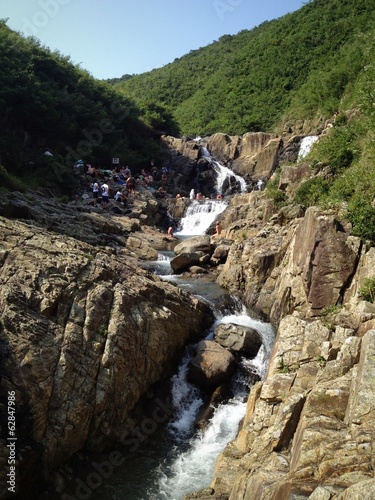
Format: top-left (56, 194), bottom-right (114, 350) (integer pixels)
top-left (187, 187), bottom-right (375, 500)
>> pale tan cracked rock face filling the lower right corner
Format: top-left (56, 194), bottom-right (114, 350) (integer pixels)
top-left (202, 322), bottom-right (375, 500)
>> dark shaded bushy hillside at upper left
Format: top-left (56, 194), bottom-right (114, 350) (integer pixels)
top-left (0, 20), bottom-right (162, 190)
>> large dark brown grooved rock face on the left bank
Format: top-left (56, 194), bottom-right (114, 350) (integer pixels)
top-left (0, 213), bottom-right (213, 492)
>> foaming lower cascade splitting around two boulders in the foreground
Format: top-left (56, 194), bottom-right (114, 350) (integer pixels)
top-left (148, 311), bottom-right (274, 500)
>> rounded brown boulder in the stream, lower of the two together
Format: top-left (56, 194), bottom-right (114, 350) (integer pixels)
top-left (188, 340), bottom-right (237, 392)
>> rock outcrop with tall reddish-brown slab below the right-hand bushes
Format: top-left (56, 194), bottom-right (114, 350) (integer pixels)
top-left (218, 201), bottom-right (361, 324)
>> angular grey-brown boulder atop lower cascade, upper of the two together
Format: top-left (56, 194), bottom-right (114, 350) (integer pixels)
top-left (214, 323), bottom-right (262, 357)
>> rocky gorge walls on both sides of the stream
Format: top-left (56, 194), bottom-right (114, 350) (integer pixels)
top-left (0, 127), bottom-right (375, 500)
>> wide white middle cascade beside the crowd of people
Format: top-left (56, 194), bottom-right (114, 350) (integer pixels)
top-left (175, 200), bottom-right (227, 236)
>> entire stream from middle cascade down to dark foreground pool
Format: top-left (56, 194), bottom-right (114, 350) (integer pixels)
top-left (59, 162), bottom-right (274, 500)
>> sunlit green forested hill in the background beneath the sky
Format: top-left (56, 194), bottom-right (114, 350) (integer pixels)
top-left (113, 0), bottom-right (375, 135)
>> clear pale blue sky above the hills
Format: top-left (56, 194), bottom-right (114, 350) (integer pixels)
top-left (0, 0), bottom-right (308, 78)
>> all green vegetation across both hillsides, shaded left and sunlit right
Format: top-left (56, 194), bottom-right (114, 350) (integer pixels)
top-left (0, 0), bottom-right (375, 241)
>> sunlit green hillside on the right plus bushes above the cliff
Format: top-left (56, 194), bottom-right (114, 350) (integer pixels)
top-left (113, 0), bottom-right (375, 240)
